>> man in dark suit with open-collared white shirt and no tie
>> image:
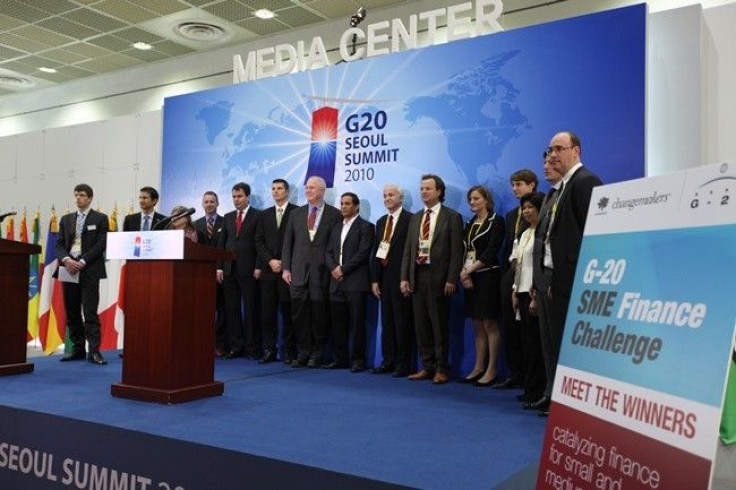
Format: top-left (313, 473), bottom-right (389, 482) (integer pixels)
top-left (322, 192), bottom-right (375, 373)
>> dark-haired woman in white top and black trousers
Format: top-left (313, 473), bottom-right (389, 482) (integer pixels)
top-left (511, 192), bottom-right (547, 409)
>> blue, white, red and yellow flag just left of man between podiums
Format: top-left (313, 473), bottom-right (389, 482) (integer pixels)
top-left (38, 207), bottom-right (66, 354)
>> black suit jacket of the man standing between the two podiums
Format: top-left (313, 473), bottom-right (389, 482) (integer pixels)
top-left (54, 209), bottom-right (110, 279)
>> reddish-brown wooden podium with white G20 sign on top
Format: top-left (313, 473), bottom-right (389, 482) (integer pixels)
top-left (108, 232), bottom-right (232, 404)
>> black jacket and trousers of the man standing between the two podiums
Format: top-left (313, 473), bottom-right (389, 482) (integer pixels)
top-left (55, 209), bottom-right (110, 354)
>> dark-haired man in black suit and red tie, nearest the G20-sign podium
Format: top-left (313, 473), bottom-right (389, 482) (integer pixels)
top-left (217, 182), bottom-right (261, 359)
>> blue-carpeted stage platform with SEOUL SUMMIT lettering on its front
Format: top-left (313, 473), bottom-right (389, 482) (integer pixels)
top-left (0, 352), bottom-right (546, 490)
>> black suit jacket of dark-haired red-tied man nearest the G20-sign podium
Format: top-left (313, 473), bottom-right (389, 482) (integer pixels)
top-left (218, 206), bottom-right (261, 277)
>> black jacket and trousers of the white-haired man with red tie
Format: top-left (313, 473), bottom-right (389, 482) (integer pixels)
top-left (371, 209), bottom-right (413, 373)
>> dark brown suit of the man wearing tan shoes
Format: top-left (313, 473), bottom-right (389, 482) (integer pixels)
top-left (401, 206), bottom-right (463, 374)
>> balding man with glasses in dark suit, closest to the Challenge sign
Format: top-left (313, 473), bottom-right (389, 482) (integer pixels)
top-left (535, 131), bottom-right (603, 412)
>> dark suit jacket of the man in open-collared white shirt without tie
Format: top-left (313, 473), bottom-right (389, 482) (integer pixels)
top-left (325, 216), bottom-right (376, 293)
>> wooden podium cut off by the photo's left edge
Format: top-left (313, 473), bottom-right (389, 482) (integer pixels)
top-left (0, 239), bottom-right (41, 376)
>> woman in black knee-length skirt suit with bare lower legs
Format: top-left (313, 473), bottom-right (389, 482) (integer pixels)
top-left (460, 185), bottom-right (504, 387)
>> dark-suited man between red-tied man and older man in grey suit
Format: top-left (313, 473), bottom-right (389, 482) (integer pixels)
top-left (256, 179), bottom-right (297, 364)
